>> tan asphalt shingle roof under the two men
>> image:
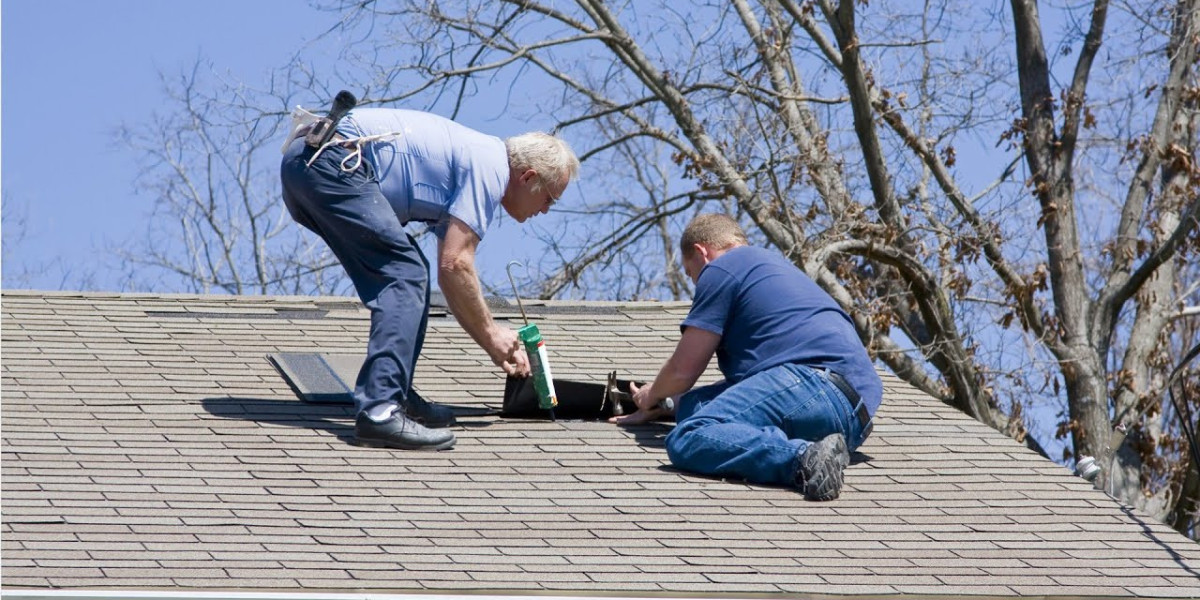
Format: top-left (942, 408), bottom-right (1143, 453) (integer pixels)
top-left (0, 292), bottom-right (1200, 598)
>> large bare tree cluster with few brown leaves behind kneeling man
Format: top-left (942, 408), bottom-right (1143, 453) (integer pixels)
top-left (297, 0), bottom-right (1200, 530)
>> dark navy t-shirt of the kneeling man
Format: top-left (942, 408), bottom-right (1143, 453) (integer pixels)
top-left (680, 246), bottom-right (883, 415)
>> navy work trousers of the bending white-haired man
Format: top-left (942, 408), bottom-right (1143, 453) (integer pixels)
top-left (280, 138), bottom-right (430, 413)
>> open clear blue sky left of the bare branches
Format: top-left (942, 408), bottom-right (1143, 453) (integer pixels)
top-left (0, 0), bottom-right (350, 289)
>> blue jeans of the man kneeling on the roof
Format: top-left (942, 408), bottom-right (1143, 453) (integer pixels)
top-left (666, 365), bottom-right (864, 486)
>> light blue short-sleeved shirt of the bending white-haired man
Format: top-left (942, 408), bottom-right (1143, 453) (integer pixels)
top-left (337, 108), bottom-right (509, 239)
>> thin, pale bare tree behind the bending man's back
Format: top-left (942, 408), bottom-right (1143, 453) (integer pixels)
top-left (118, 60), bottom-right (349, 294)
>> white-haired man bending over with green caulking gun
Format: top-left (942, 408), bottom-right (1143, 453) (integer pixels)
top-left (281, 108), bottom-right (580, 450)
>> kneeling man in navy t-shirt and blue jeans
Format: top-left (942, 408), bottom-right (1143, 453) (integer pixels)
top-left (614, 215), bottom-right (882, 500)
